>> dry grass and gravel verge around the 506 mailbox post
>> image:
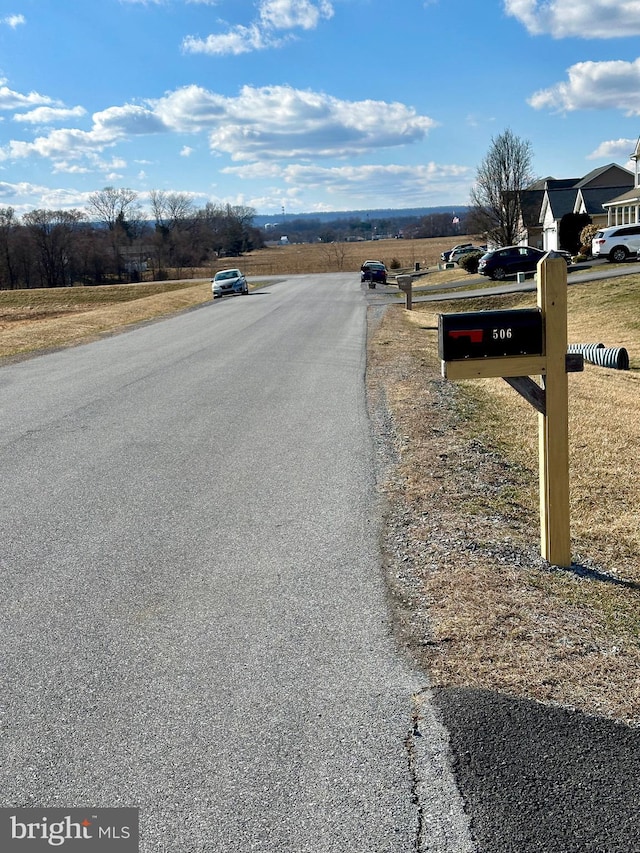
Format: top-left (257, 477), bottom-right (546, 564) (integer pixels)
top-left (370, 276), bottom-right (640, 724)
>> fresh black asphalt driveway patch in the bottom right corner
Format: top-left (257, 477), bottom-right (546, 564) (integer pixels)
top-left (434, 688), bottom-right (640, 853)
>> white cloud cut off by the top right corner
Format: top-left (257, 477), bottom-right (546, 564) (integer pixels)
top-left (504, 0), bottom-right (640, 38)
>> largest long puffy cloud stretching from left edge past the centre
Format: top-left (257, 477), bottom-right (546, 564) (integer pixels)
top-left (0, 80), bottom-right (436, 179)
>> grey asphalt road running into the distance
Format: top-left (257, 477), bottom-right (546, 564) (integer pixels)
top-left (0, 275), bottom-right (470, 853)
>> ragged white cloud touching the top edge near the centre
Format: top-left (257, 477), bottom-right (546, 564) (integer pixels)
top-left (182, 0), bottom-right (333, 56)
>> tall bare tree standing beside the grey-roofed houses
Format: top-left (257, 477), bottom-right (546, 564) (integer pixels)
top-left (467, 130), bottom-right (535, 246)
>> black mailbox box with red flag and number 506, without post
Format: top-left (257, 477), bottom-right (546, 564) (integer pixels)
top-left (438, 308), bottom-right (543, 361)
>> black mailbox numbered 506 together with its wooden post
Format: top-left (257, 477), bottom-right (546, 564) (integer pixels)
top-left (438, 257), bottom-right (583, 567)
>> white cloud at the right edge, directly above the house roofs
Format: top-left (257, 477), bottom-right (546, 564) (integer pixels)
top-left (528, 58), bottom-right (640, 116)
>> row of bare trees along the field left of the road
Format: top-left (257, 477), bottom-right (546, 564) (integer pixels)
top-left (0, 187), bottom-right (263, 290)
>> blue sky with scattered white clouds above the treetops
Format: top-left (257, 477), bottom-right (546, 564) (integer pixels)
top-left (0, 0), bottom-right (640, 215)
